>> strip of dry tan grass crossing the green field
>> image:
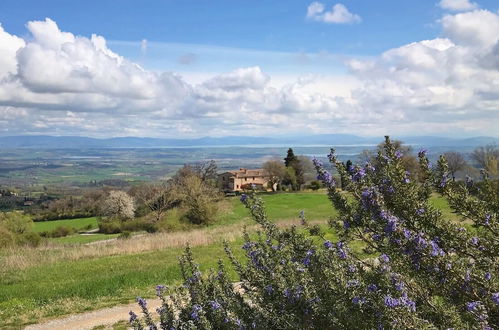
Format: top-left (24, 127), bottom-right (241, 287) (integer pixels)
top-left (0, 219), bottom-right (316, 274)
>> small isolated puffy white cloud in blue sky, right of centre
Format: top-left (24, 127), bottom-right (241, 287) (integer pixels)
top-left (307, 1), bottom-right (362, 24)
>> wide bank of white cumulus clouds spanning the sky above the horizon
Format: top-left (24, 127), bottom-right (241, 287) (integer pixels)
top-left (0, 11), bottom-right (499, 136)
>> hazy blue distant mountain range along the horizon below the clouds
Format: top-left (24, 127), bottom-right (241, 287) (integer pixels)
top-left (0, 134), bottom-right (499, 149)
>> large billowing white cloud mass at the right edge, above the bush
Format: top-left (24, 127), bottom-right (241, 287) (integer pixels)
top-left (350, 10), bottom-right (499, 131)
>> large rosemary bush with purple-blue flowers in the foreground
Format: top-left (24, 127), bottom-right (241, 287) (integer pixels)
top-left (130, 138), bottom-right (499, 329)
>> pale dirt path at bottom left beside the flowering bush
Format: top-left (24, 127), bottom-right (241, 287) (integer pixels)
top-left (25, 299), bottom-right (161, 330)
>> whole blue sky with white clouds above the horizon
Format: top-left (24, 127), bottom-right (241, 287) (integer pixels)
top-left (0, 0), bottom-right (499, 138)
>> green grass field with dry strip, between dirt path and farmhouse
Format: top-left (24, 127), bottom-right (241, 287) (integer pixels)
top-left (0, 192), bottom-right (464, 327)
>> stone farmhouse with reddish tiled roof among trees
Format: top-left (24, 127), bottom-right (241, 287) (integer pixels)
top-left (218, 168), bottom-right (269, 191)
